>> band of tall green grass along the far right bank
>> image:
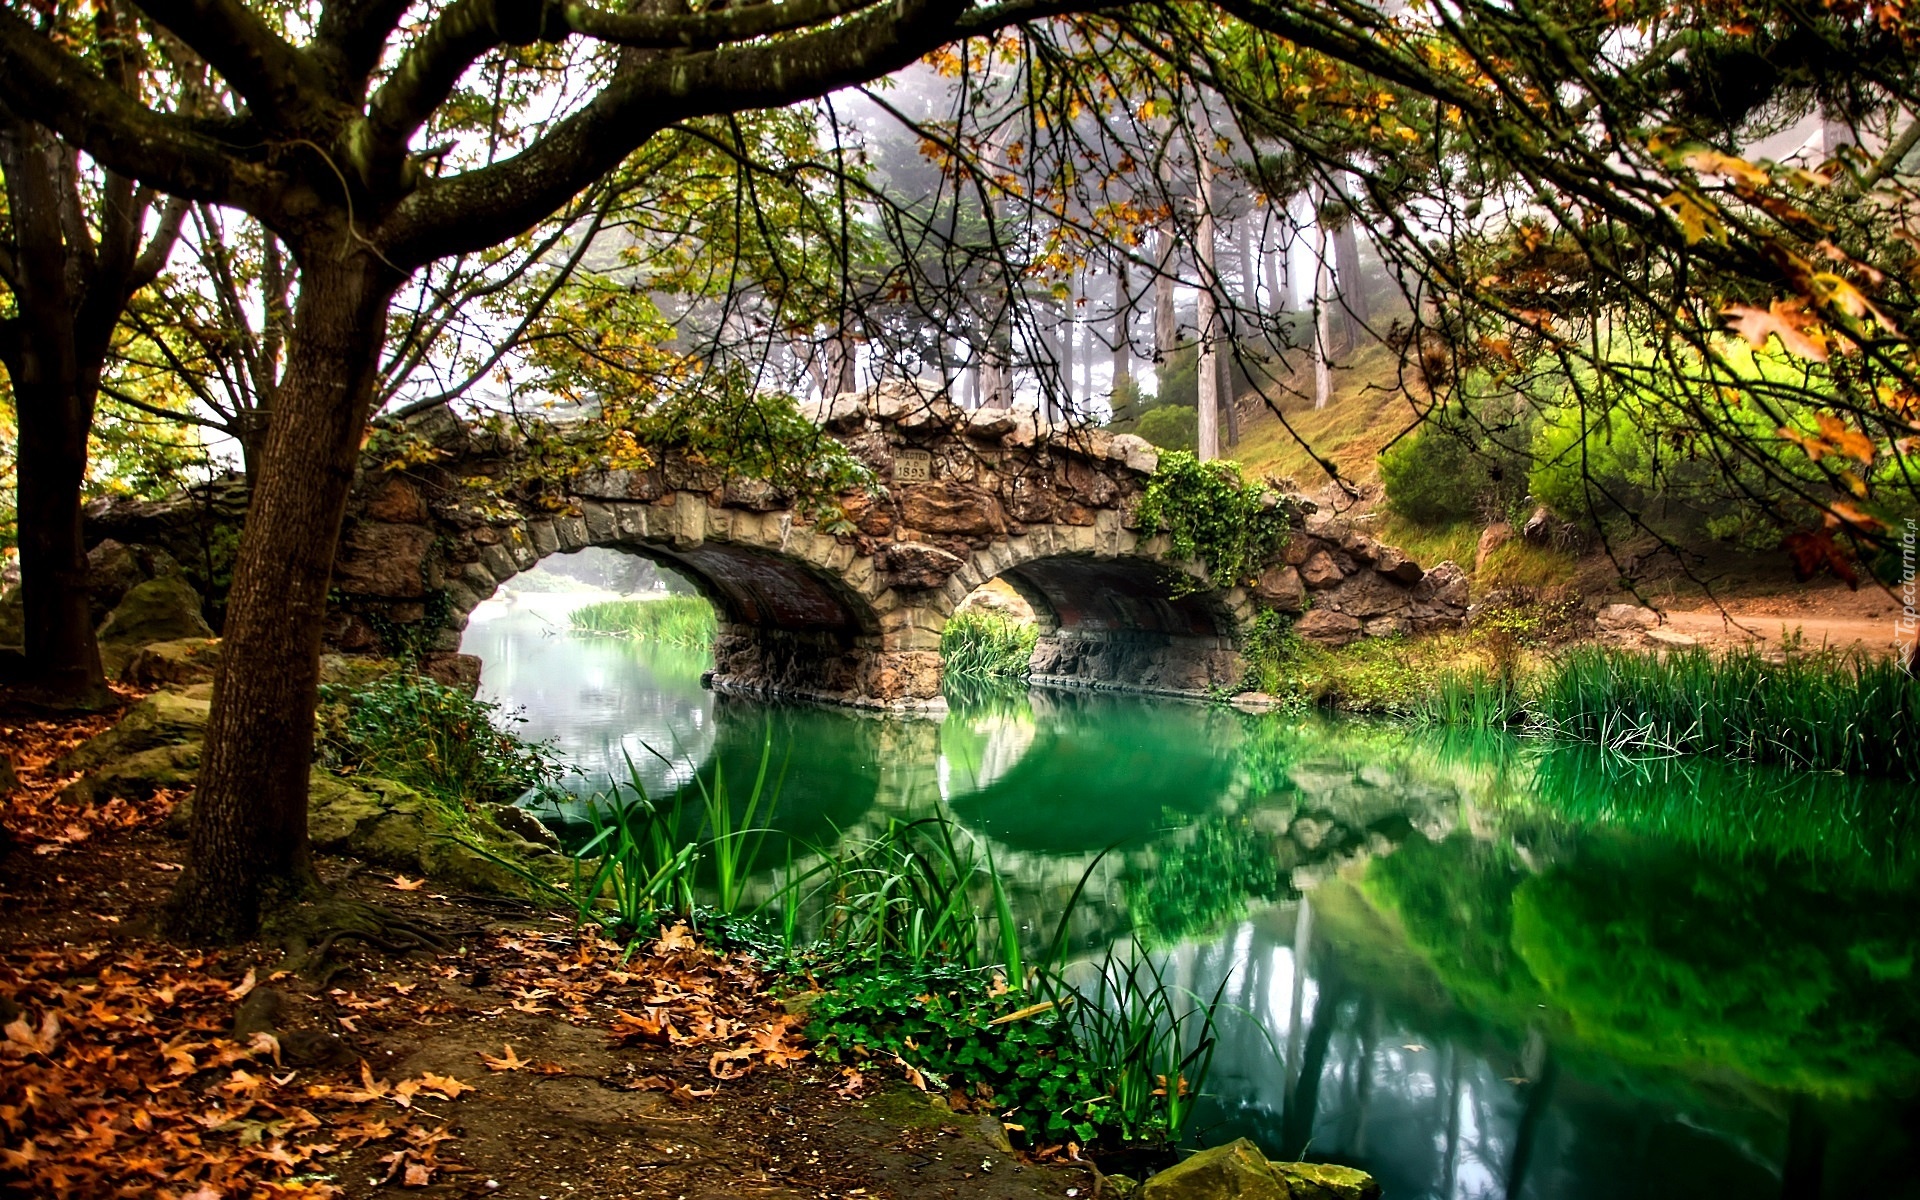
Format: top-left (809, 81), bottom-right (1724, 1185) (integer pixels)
top-left (1528, 647), bottom-right (1920, 780)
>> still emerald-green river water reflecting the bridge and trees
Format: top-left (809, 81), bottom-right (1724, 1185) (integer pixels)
top-left (465, 597), bottom-right (1920, 1200)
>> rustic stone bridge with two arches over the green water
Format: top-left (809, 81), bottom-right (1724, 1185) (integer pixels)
top-left (96, 384), bottom-right (1465, 707)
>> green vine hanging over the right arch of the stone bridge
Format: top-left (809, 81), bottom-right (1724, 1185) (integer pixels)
top-left (1139, 449), bottom-right (1294, 593)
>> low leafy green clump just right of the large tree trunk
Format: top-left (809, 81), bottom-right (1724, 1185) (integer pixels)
top-left (319, 672), bottom-right (563, 816)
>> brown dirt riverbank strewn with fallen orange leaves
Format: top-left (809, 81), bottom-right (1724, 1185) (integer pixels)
top-left (0, 752), bottom-right (1098, 1200)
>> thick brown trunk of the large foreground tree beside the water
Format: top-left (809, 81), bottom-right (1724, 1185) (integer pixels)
top-left (169, 246), bottom-right (401, 941)
